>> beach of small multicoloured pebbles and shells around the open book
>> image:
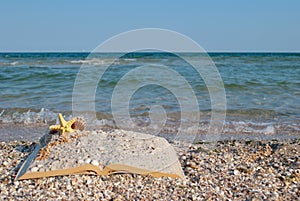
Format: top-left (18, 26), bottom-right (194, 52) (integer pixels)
top-left (0, 130), bottom-right (300, 200)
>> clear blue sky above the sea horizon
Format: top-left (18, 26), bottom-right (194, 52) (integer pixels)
top-left (0, 0), bottom-right (300, 52)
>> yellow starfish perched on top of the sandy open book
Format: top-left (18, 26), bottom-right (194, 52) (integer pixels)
top-left (49, 113), bottom-right (77, 136)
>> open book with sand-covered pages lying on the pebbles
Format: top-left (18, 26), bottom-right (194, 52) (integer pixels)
top-left (16, 130), bottom-right (184, 180)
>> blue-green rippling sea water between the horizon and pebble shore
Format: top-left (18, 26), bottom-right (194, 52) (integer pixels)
top-left (0, 52), bottom-right (300, 141)
